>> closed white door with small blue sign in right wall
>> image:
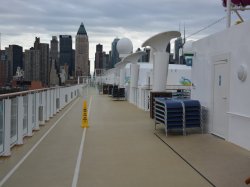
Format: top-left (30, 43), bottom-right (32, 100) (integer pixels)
top-left (212, 60), bottom-right (230, 139)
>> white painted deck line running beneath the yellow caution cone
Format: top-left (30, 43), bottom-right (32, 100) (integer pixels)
top-left (71, 96), bottom-right (92, 187)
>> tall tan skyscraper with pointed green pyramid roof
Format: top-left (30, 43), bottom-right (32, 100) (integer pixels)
top-left (75, 23), bottom-right (90, 77)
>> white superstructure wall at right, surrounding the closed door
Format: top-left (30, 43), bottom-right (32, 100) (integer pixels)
top-left (191, 19), bottom-right (250, 150)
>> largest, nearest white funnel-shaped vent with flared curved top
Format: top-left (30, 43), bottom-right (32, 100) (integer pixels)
top-left (142, 31), bottom-right (181, 91)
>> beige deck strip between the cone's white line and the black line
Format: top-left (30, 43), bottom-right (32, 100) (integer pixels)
top-left (78, 89), bottom-right (210, 187)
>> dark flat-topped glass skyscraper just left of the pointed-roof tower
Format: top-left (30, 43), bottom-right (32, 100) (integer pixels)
top-left (59, 35), bottom-right (74, 76)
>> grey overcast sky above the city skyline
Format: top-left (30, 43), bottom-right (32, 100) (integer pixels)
top-left (0, 0), bottom-right (250, 71)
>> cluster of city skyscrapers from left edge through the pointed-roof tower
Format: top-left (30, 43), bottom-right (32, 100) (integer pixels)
top-left (0, 23), bottom-right (90, 89)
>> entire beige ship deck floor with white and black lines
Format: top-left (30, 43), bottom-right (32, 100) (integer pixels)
top-left (0, 87), bottom-right (250, 187)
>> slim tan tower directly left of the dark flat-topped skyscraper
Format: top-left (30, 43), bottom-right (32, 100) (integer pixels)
top-left (50, 36), bottom-right (60, 73)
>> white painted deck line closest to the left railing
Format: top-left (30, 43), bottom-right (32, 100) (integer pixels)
top-left (0, 98), bottom-right (79, 187)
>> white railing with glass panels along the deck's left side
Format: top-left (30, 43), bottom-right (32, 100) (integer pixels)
top-left (0, 85), bottom-right (83, 156)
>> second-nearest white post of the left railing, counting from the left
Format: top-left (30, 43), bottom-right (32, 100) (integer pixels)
top-left (17, 96), bottom-right (24, 145)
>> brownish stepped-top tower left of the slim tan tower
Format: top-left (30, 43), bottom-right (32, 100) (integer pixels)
top-left (34, 37), bottom-right (50, 86)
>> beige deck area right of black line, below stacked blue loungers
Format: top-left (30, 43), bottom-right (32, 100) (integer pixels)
top-left (156, 129), bottom-right (250, 187)
